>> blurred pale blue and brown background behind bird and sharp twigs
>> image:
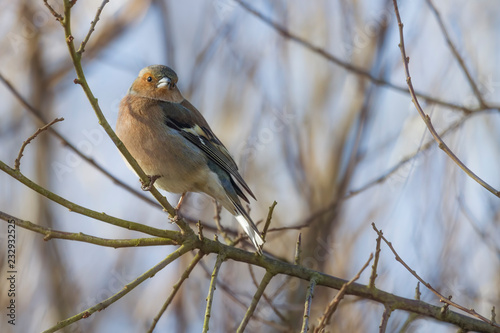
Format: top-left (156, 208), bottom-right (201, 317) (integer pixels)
top-left (0, 0), bottom-right (500, 332)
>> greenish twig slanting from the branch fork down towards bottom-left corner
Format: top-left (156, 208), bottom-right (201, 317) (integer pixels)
top-left (43, 245), bottom-right (192, 333)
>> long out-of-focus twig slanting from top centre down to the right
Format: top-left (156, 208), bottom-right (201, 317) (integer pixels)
top-left (234, 0), bottom-right (476, 113)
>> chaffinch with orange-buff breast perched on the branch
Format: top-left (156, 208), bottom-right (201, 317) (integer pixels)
top-left (116, 65), bottom-right (264, 254)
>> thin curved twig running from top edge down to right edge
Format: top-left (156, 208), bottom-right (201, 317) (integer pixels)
top-left (393, 0), bottom-right (500, 198)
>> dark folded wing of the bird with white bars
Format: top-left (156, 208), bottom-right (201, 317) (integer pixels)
top-left (161, 100), bottom-right (255, 202)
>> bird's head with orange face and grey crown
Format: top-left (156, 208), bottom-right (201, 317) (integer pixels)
top-left (129, 65), bottom-right (184, 103)
